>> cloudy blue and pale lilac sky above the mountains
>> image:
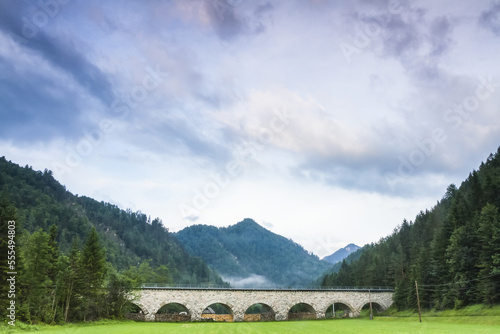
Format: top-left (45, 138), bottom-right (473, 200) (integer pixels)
top-left (0, 0), bottom-right (500, 256)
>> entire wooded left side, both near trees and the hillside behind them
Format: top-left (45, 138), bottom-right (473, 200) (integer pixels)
top-left (0, 157), bottom-right (227, 323)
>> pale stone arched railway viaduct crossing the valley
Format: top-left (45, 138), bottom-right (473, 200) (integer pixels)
top-left (134, 288), bottom-right (393, 321)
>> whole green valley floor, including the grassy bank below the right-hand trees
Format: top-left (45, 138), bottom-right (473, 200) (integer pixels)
top-left (4, 304), bottom-right (500, 334)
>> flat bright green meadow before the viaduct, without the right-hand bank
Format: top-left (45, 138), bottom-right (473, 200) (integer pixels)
top-left (2, 316), bottom-right (500, 334)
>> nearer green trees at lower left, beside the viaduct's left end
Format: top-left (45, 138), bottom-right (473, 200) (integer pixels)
top-left (0, 196), bottom-right (176, 323)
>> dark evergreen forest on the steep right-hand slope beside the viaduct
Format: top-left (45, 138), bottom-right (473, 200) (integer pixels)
top-left (321, 148), bottom-right (500, 310)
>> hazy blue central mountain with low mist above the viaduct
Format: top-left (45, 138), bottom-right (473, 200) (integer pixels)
top-left (176, 218), bottom-right (331, 287)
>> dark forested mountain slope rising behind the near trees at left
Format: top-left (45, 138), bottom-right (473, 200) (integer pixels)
top-left (0, 157), bottom-right (223, 284)
